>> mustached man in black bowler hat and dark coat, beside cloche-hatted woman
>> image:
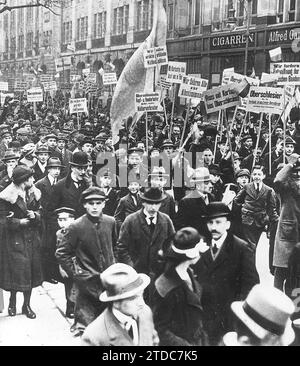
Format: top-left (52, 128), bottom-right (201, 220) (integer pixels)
top-left (194, 202), bottom-right (259, 345)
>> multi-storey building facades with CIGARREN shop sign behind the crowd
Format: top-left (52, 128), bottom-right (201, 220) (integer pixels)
top-left (0, 0), bottom-right (300, 85)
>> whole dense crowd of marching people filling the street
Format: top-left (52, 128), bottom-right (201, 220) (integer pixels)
top-left (0, 92), bottom-right (300, 347)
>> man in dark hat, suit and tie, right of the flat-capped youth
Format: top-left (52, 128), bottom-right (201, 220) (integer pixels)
top-left (117, 188), bottom-right (175, 302)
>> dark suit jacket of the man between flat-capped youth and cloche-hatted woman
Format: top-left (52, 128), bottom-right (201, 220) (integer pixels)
top-left (117, 209), bottom-right (175, 275)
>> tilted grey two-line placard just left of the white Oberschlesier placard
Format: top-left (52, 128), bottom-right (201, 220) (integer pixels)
top-left (203, 84), bottom-right (240, 114)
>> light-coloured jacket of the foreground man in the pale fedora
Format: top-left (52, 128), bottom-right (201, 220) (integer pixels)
top-left (81, 306), bottom-right (158, 347)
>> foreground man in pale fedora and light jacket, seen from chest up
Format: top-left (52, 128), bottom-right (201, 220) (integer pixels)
top-left (81, 263), bottom-right (159, 347)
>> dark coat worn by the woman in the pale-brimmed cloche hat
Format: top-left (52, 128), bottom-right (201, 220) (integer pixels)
top-left (153, 268), bottom-right (206, 347)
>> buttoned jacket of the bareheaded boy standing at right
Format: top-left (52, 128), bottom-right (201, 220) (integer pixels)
top-left (235, 182), bottom-right (278, 227)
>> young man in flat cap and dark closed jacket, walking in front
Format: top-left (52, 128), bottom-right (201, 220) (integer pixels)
top-left (56, 187), bottom-right (117, 331)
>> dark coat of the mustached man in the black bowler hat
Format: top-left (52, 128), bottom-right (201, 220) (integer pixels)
top-left (194, 234), bottom-right (259, 344)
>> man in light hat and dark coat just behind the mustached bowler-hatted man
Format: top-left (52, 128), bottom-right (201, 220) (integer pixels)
top-left (175, 168), bottom-right (215, 236)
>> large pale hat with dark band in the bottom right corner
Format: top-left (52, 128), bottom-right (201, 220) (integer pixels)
top-left (231, 285), bottom-right (295, 346)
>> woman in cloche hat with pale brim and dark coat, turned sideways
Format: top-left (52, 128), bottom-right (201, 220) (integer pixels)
top-left (153, 227), bottom-right (207, 346)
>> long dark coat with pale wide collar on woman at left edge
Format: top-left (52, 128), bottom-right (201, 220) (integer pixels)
top-left (0, 183), bottom-right (42, 292)
